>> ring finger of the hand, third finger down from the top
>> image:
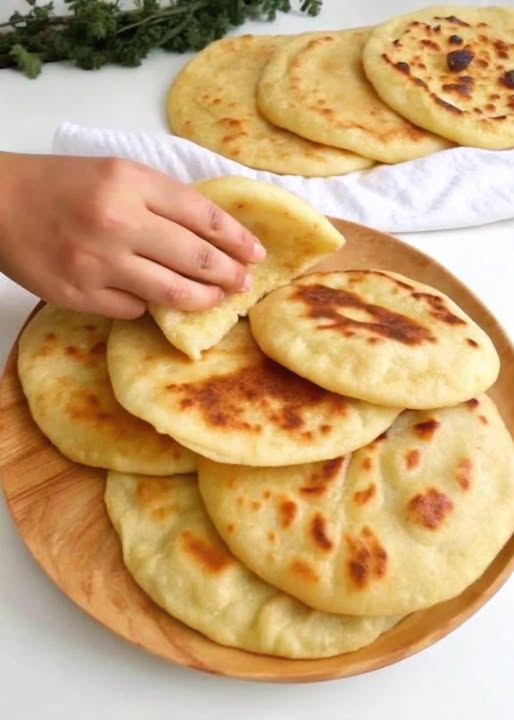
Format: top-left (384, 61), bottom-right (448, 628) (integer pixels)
top-left (112, 255), bottom-right (224, 310)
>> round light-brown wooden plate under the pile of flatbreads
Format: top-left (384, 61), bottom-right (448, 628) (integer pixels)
top-left (0, 221), bottom-right (514, 682)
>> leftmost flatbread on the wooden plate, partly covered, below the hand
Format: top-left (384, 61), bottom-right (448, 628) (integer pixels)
top-left (18, 305), bottom-right (196, 475)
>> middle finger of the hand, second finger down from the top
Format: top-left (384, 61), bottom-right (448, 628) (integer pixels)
top-left (132, 215), bottom-right (252, 292)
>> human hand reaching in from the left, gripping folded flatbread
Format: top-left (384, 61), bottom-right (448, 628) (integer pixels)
top-left (0, 153), bottom-right (265, 319)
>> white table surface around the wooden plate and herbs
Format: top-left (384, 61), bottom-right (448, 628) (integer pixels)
top-left (0, 0), bottom-right (514, 720)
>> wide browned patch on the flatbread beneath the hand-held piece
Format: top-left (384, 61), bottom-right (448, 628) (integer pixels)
top-left (166, 350), bottom-right (348, 430)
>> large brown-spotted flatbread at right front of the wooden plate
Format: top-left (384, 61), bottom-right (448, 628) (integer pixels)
top-left (198, 396), bottom-right (514, 615)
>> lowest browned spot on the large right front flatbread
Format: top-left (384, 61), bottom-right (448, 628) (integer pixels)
top-left (345, 526), bottom-right (387, 590)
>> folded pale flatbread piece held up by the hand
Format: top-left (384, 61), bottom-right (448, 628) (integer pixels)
top-left (149, 175), bottom-right (345, 359)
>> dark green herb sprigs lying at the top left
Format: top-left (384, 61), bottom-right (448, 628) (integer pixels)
top-left (0, 0), bottom-right (323, 78)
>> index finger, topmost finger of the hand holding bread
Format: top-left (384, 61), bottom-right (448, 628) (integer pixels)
top-left (145, 173), bottom-right (266, 263)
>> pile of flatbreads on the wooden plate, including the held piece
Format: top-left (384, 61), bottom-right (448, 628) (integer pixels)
top-left (18, 177), bottom-right (514, 658)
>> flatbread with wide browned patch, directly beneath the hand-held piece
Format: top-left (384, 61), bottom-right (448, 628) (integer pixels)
top-left (107, 317), bottom-right (399, 465)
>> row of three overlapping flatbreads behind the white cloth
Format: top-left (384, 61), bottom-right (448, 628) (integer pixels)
top-left (167, 6), bottom-right (514, 177)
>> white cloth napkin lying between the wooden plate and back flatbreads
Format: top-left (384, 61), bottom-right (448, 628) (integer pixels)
top-left (53, 123), bottom-right (514, 232)
